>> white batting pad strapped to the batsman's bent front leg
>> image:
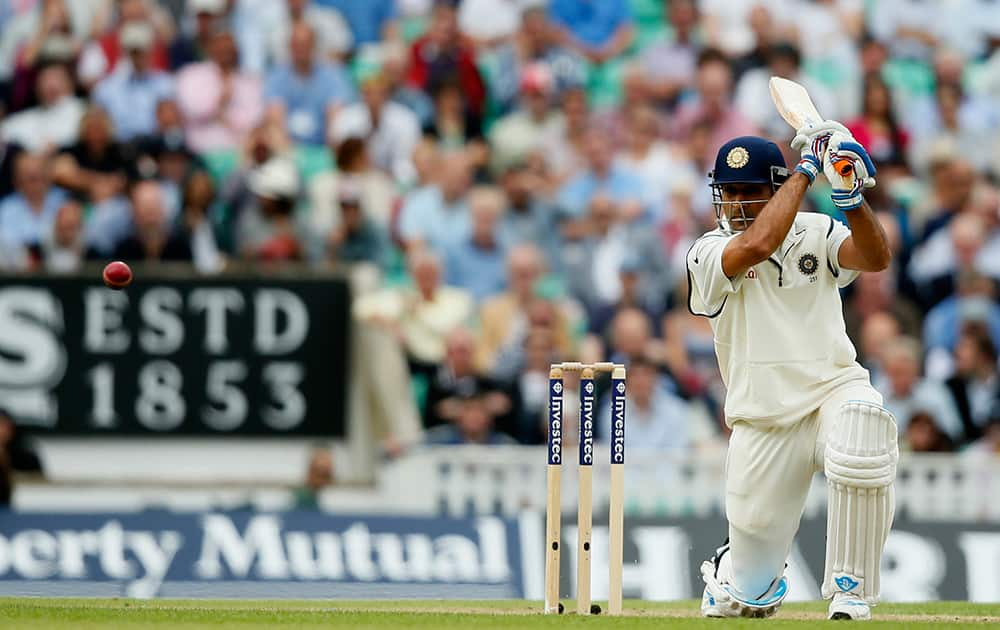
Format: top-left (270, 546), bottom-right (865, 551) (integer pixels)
top-left (823, 401), bottom-right (899, 604)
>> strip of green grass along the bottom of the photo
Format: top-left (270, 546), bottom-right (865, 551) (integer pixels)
top-left (0, 597), bottom-right (1000, 630)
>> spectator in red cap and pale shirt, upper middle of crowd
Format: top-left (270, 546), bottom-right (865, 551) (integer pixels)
top-left (489, 63), bottom-right (562, 172)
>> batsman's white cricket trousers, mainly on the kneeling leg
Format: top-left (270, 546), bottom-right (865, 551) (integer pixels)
top-left (726, 381), bottom-right (882, 598)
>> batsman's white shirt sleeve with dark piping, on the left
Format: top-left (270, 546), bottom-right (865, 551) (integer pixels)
top-left (687, 232), bottom-right (743, 317)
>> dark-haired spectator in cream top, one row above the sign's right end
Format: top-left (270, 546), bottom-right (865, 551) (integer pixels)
top-left (309, 138), bottom-right (397, 234)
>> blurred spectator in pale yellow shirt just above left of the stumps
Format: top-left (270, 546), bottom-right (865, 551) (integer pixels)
top-left (476, 243), bottom-right (570, 378)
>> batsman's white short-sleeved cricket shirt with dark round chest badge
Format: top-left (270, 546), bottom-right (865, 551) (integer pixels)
top-left (687, 212), bottom-right (868, 426)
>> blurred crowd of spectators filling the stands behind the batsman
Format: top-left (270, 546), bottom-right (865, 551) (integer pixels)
top-left (0, 0), bottom-right (1000, 470)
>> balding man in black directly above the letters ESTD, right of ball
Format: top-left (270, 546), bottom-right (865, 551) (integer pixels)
top-left (114, 180), bottom-right (191, 263)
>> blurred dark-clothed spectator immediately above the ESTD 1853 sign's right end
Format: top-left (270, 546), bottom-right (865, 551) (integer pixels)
top-left (326, 178), bottom-right (389, 268)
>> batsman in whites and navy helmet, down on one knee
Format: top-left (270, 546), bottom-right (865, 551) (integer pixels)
top-left (687, 121), bottom-right (899, 619)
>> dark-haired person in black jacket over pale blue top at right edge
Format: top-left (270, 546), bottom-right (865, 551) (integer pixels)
top-left (945, 322), bottom-right (1000, 442)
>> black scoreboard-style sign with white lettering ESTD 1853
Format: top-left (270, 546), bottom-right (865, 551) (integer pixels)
top-left (0, 277), bottom-right (350, 435)
